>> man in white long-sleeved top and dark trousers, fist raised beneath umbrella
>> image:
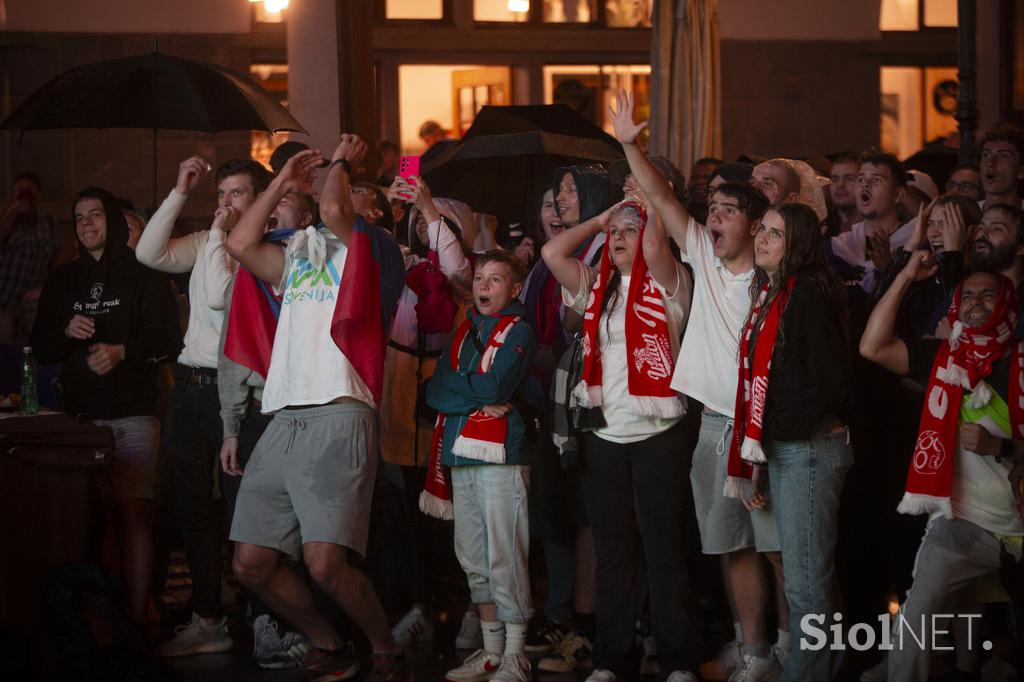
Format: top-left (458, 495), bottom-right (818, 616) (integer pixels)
top-left (135, 157), bottom-right (270, 656)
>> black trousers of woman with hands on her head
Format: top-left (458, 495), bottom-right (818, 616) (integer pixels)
top-left (582, 422), bottom-right (699, 680)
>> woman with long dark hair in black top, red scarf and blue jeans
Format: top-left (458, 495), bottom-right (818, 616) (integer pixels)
top-left (725, 203), bottom-right (853, 682)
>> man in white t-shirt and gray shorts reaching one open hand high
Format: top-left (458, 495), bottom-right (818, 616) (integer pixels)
top-left (615, 91), bottom-right (788, 679)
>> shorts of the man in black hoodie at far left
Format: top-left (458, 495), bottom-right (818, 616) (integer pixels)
top-left (92, 417), bottom-right (160, 500)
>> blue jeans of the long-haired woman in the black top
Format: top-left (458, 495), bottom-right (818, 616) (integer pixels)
top-left (767, 421), bottom-right (853, 682)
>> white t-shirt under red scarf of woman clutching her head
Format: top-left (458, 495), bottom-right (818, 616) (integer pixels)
top-left (562, 263), bottom-right (691, 442)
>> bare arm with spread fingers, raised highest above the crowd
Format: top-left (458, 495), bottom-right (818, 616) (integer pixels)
top-left (608, 90), bottom-right (690, 250)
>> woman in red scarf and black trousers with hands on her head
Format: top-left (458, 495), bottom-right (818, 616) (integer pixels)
top-left (542, 197), bottom-right (698, 682)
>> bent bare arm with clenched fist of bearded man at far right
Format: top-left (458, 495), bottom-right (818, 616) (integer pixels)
top-left (860, 251), bottom-right (938, 376)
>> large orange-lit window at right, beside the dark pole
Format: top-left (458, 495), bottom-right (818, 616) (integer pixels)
top-left (881, 67), bottom-right (957, 159)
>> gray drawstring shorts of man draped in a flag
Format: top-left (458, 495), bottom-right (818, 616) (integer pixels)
top-left (231, 402), bottom-right (377, 558)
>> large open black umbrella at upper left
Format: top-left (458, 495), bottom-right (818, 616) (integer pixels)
top-left (0, 51), bottom-right (306, 206)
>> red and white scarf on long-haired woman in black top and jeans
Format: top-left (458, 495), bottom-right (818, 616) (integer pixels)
top-left (723, 278), bottom-right (796, 500)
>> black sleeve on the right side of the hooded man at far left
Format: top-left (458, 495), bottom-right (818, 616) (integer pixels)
top-left (125, 268), bottom-right (182, 367)
